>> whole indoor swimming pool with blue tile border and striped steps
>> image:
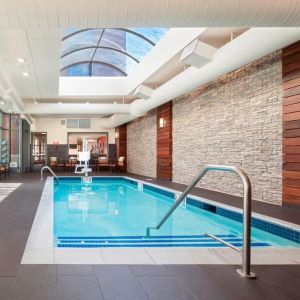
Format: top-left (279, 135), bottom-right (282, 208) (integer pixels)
top-left (52, 177), bottom-right (300, 248)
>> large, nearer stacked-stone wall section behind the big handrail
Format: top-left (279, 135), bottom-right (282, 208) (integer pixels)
top-left (172, 52), bottom-right (282, 204)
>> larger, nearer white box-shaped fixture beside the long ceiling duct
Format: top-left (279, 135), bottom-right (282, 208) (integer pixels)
top-left (180, 40), bottom-right (217, 68)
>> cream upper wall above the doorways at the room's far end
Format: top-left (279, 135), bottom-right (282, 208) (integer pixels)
top-left (32, 118), bottom-right (115, 144)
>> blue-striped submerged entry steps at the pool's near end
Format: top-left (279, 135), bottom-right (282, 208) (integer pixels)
top-left (57, 234), bottom-right (270, 248)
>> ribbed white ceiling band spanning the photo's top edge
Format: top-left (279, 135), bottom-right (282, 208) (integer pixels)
top-left (0, 0), bottom-right (300, 29)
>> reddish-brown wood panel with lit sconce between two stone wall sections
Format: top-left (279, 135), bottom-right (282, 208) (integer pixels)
top-left (156, 101), bottom-right (172, 180)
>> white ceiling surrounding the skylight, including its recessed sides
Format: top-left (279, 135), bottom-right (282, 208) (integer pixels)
top-left (0, 28), bottom-right (298, 117)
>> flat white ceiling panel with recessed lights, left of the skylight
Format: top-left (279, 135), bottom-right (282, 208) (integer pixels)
top-left (0, 29), bottom-right (60, 99)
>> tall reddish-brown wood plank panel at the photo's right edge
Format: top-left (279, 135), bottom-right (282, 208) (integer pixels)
top-left (282, 41), bottom-right (300, 206)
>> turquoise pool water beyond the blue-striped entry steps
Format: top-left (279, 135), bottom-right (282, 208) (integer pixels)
top-left (54, 179), bottom-right (300, 247)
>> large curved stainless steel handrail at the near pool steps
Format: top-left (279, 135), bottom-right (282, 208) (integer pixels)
top-left (146, 165), bottom-right (256, 278)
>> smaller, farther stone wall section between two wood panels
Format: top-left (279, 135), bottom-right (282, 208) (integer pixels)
top-left (127, 110), bottom-right (156, 177)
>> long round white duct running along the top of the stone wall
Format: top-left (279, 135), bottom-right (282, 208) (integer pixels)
top-left (100, 27), bottom-right (300, 128)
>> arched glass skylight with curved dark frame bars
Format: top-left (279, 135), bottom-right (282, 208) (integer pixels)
top-left (61, 28), bottom-right (168, 76)
